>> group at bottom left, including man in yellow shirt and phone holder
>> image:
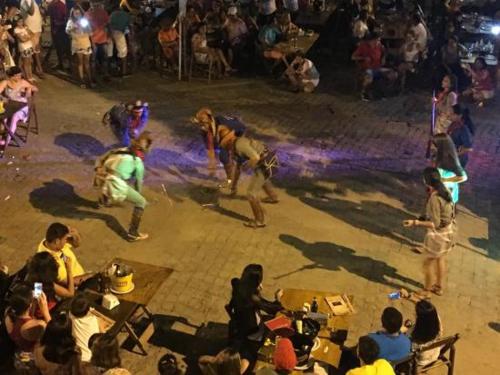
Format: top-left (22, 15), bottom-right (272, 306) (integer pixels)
top-left (0, 223), bottom-right (130, 375)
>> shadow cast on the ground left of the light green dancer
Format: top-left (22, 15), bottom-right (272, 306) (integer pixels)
top-left (30, 179), bottom-right (127, 238)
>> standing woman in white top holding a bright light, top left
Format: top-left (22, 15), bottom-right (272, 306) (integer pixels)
top-left (66, 6), bottom-right (92, 88)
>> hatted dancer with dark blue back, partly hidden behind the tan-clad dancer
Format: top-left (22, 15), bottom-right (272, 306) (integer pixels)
top-left (192, 108), bottom-right (246, 194)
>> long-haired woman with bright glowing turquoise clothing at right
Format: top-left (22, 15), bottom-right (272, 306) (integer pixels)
top-left (433, 133), bottom-right (467, 204)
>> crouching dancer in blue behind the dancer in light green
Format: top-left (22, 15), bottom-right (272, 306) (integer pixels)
top-left (102, 100), bottom-right (149, 147)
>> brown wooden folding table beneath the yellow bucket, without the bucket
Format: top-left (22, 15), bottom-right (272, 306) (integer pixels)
top-left (87, 258), bottom-right (173, 355)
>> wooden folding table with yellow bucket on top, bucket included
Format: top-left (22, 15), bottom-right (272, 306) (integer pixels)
top-left (86, 258), bottom-right (173, 355)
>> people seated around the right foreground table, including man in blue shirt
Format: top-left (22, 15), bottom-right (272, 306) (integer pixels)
top-left (199, 264), bottom-right (443, 375)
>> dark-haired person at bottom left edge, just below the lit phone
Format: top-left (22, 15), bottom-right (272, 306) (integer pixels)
top-left (34, 313), bottom-right (83, 375)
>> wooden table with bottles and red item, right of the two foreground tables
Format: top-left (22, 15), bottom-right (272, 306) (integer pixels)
top-left (256, 289), bottom-right (354, 371)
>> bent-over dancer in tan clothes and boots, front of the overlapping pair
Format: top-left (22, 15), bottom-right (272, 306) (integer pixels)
top-left (219, 129), bottom-right (278, 229)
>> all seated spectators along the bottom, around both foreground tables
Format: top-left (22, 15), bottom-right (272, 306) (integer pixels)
top-left (0, 223), bottom-right (450, 375)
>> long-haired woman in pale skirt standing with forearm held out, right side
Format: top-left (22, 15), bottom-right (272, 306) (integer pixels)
top-left (403, 167), bottom-right (456, 298)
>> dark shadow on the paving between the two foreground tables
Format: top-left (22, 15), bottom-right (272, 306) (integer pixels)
top-left (149, 314), bottom-right (228, 374)
